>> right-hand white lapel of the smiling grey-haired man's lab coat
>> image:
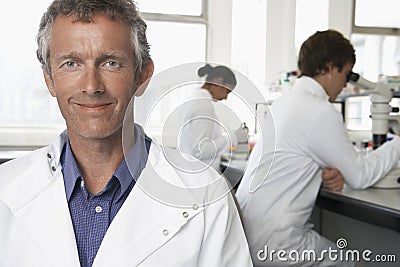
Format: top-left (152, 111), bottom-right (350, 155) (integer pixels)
top-left (93, 146), bottom-right (203, 267)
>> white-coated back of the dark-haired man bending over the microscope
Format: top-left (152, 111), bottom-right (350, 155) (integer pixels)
top-left (236, 76), bottom-right (348, 266)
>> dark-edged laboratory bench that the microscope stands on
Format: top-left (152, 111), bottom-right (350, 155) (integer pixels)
top-left (221, 160), bottom-right (400, 267)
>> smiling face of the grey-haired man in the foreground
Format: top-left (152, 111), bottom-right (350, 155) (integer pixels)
top-left (45, 14), bottom-right (145, 139)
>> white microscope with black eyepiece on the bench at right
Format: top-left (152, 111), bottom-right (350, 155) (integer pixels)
top-left (347, 72), bottom-right (400, 188)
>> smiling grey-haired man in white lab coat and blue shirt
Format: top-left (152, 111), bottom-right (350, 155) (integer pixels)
top-left (0, 0), bottom-right (252, 267)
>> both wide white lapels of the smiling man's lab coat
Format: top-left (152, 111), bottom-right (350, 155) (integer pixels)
top-left (0, 129), bottom-right (204, 267)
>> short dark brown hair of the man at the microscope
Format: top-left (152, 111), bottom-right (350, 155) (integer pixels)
top-left (298, 30), bottom-right (356, 77)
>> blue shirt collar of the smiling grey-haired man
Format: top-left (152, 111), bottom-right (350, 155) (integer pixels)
top-left (61, 124), bottom-right (151, 201)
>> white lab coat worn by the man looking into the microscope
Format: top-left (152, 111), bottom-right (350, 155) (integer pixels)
top-left (236, 77), bottom-right (400, 266)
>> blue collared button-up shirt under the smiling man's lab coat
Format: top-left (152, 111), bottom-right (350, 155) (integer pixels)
top-left (61, 128), bottom-right (151, 266)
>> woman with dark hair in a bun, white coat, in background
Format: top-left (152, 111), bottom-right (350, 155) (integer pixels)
top-left (178, 64), bottom-right (237, 171)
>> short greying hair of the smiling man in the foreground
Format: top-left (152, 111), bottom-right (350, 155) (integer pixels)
top-left (36, 0), bottom-right (151, 76)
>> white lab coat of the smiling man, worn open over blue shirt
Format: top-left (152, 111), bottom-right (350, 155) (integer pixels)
top-left (0, 126), bottom-right (252, 267)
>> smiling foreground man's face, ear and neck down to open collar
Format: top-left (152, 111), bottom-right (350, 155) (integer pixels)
top-left (44, 14), bottom-right (153, 197)
